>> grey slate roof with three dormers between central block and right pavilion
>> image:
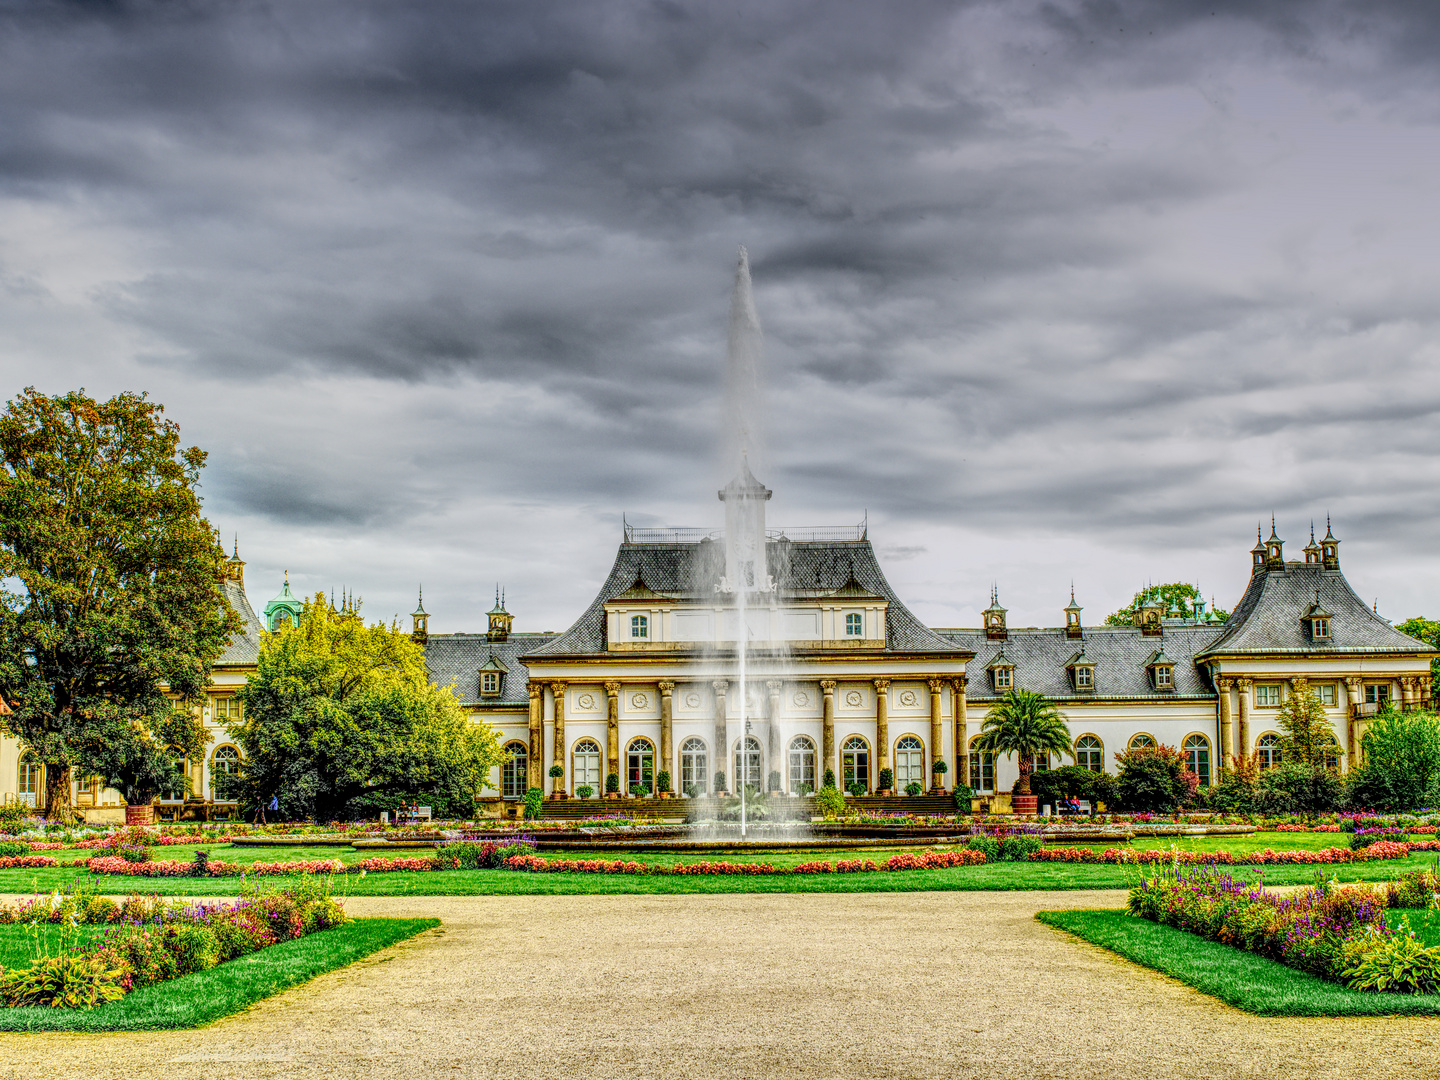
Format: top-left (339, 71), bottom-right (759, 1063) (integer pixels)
top-left (936, 624), bottom-right (1224, 701)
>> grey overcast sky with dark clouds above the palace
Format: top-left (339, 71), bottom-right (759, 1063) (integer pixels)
top-left (0, 0), bottom-right (1440, 632)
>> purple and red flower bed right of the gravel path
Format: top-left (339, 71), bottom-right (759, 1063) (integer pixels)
top-left (1126, 867), bottom-right (1440, 992)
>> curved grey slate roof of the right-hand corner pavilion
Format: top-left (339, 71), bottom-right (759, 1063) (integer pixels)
top-left (1200, 562), bottom-right (1436, 657)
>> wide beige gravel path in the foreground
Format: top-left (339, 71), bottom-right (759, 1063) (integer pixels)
top-left (0, 893), bottom-right (1440, 1080)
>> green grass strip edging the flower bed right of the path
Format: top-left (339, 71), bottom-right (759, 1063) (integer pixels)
top-left (1035, 909), bottom-right (1440, 1017)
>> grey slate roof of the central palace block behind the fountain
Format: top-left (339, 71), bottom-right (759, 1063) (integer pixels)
top-left (529, 539), bottom-right (959, 657)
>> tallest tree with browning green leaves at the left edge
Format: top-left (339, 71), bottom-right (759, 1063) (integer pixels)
top-left (0, 389), bottom-right (240, 818)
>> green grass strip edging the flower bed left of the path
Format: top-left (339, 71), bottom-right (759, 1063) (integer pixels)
top-left (0, 919), bottom-right (441, 1031)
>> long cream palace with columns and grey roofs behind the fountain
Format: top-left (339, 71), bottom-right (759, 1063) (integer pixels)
top-left (0, 469), bottom-right (1436, 819)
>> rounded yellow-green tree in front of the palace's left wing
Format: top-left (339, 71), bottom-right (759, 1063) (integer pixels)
top-left (228, 593), bottom-right (505, 821)
